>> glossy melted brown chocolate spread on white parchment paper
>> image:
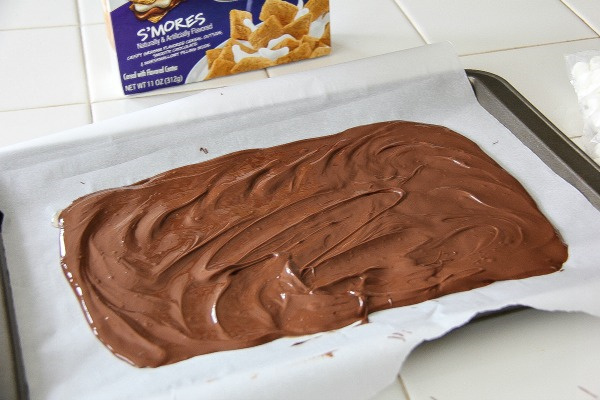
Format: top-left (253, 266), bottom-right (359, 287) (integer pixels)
top-left (60, 121), bottom-right (567, 367)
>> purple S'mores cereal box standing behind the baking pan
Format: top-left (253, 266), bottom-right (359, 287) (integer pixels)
top-left (104, 0), bottom-right (331, 94)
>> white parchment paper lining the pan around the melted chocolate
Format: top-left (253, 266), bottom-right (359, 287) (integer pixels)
top-left (0, 44), bottom-right (600, 399)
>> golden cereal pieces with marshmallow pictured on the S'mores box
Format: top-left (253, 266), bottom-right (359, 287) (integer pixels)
top-left (200, 0), bottom-right (331, 80)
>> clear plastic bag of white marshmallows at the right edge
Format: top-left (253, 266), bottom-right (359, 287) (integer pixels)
top-left (565, 50), bottom-right (600, 163)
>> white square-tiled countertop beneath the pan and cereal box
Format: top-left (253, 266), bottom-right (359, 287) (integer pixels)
top-left (0, 0), bottom-right (600, 400)
